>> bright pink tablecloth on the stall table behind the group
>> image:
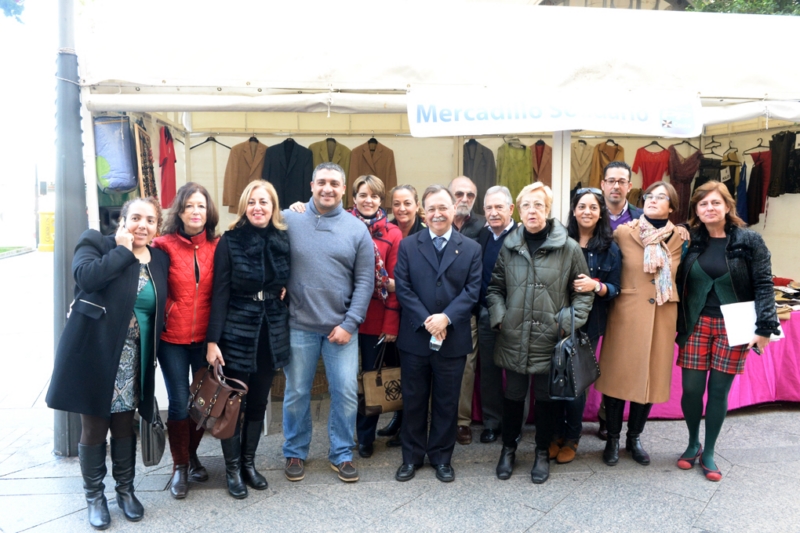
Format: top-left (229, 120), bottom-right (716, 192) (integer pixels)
top-left (472, 312), bottom-right (800, 421)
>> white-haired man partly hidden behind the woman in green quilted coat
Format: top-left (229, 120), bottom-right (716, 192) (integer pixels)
top-left (477, 185), bottom-right (517, 443)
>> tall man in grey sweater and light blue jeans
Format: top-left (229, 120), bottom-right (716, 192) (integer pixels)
top-left (283, 163), bottom-right (375, 482)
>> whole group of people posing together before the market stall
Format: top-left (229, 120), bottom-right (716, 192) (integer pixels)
top-left (47, 162), bottom-right (778, 529)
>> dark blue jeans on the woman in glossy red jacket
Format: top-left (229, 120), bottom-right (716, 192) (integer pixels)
top-left (158, 341), bottom-right (207, 422)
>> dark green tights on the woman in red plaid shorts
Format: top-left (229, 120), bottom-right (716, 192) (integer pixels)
top-left (681, 368), bottom-right (736, 470)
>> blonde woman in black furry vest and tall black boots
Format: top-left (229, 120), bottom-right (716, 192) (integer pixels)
top-left (206, 180), bottom-right (289, 499)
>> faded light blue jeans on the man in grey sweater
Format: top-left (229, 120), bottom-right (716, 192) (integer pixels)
top-left (283, 328), bottom-right (358, 465)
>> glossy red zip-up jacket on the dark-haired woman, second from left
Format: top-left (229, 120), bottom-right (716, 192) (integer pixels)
top-left (153, 231), bottom-right (219, 344)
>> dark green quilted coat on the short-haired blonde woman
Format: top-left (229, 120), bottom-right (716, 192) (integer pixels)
top-left (486, 219), bottom-right (594, 374)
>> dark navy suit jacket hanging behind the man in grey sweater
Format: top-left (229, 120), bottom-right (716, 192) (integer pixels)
top-left (261, 139), bottom-right (314, 209)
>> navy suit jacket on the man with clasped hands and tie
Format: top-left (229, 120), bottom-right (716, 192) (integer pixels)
top-left (394, 228), bottom-right (482, 357)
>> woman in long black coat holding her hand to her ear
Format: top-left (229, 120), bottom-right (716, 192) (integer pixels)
top-left (47, 198), bottom-right (169, 529)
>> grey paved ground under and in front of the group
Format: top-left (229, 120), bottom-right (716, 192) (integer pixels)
top-left (0, 253), bottom-right (800, 533)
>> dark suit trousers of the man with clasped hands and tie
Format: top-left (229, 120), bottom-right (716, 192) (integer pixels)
top-left (400, 351), bottom-right (467, 465)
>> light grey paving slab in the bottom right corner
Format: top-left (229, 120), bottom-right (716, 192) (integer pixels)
top-left (695, 465), bottom-right (800, 533)
